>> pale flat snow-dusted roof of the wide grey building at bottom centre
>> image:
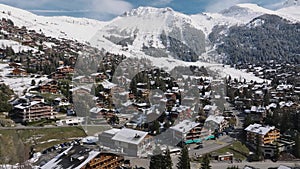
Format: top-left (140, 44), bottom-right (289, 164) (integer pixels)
top-left (112, 128), bottom-right (148, 145)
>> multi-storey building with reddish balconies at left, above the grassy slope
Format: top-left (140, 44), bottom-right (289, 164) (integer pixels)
top-left (14, 101), bottom-right (57, 122)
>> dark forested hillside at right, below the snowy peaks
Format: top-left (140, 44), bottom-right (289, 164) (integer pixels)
top-left (210, 14), bottom-right (300, 64)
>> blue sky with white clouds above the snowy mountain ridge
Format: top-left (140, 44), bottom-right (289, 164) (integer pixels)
top-left (0, 0), bottom-right (287, 21)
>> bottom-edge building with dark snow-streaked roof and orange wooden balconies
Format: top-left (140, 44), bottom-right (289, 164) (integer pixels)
top-left (39, 145), bottom-right (124, 169)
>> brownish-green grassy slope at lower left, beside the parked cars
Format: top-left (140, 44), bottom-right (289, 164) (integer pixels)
top-left (0, 127), bottom-right (86, 164)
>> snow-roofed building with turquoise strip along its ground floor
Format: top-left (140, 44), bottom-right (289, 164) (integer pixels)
top-left (170, 120), bottom-right (202, 145)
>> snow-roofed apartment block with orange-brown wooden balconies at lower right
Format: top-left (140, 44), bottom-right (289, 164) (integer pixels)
top-left (245, 123), bottom-right (280, 145)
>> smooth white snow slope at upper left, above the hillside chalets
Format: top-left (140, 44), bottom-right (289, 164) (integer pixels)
top-left (0, 4), bottom-right (106, 42)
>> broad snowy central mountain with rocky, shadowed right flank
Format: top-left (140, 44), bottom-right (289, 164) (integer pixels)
top-left (92, 7), bottom-right (205, 61)
